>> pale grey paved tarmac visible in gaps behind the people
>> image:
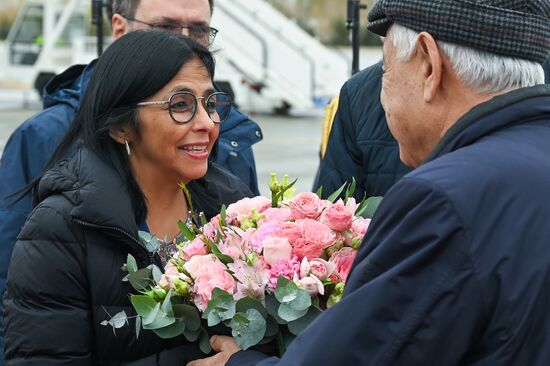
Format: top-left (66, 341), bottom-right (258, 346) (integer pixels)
top-left (0, 89), bottom-right (323, 197)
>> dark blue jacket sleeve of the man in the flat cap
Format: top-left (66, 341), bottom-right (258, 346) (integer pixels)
top-left (228, 179), bottom-right (489, 366)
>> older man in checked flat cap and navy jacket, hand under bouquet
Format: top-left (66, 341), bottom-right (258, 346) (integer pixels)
top-left (189, 0), bottom-right (550, 366)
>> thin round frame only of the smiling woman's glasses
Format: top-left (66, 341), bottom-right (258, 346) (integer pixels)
top-left (136, 91), bottom-right (233, 124)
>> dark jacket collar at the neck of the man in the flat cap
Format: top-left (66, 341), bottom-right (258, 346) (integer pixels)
top-left (422, 85), bottom-right (550, 164)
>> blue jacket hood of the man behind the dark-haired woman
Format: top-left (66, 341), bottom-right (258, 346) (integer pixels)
top-left (43, 61), bottom-right (96, 109)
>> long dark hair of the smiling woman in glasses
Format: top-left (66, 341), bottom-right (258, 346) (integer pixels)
top-left (32, 30), bottom-right (214, 222)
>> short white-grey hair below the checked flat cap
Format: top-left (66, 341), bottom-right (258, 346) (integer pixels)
top-left (387, 23), bottom-right (544, 94)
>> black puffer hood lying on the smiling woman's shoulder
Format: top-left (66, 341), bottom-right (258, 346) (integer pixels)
top-left (38, 148), bottom-right (138, 237)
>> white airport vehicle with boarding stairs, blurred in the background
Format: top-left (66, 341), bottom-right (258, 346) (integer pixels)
top-left (0, 0), bottom-right (350, 112)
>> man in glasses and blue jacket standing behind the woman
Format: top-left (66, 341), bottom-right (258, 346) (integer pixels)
top-left (0, 0), bottom-right (262, 366)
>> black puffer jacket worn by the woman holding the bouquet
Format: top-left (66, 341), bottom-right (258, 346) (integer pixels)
top-left (4, 150), bottom-right (251, 366)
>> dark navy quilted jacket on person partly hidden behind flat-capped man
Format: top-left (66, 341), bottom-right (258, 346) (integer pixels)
top-left (313, 62), bottom-right (410, 199)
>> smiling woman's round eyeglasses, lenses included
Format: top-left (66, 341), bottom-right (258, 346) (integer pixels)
top-left (136, 91), bottom-right (232, 124)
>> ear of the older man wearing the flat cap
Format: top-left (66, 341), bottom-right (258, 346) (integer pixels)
top-left (417, 32), bottom-right (443, 103)
